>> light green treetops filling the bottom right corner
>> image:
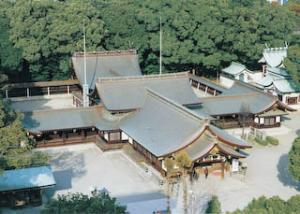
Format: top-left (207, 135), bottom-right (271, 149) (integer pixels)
top-left (228, 195), bottom-right (300, 214)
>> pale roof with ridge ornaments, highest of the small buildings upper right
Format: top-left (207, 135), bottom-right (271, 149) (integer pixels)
top-left (258, 47), bottom-right (287, 67)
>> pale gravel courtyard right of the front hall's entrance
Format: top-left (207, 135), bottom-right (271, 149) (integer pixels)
top-left (185, 112), bottom-right (300, 213)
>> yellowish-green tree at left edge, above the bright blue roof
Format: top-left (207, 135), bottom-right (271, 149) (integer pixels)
top-left (0, 99), bottom-right (48, 171)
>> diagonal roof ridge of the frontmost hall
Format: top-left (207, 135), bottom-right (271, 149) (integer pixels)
top-left (146, 88), bottom-right (206, 122)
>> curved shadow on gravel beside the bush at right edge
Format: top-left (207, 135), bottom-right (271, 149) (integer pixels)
top-left (277, 154), bottom-right (300, 191)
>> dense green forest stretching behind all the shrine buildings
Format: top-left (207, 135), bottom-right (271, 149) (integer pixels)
top-left (0, 0), bottom-right (300, 83)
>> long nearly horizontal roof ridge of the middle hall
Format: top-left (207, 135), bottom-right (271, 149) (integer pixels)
top-left (97, 71), bottom-right (189, 83)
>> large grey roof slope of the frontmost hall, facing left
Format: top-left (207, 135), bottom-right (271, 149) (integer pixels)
top-left (120, 90), bottom-right (206, 157)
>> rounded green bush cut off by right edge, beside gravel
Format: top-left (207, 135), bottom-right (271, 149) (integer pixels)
top-left (289, 137), bottom-right (300, 181)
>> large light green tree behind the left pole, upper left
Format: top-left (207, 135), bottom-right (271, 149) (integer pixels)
top-left (9, 0), bottom-right (106, 80)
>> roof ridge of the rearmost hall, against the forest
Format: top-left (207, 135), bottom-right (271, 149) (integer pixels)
top-left (72, 49), bottom-right (137, 57)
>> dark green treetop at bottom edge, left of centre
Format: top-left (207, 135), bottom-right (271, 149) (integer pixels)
top-left (41, 192), bottom-right (126, 214)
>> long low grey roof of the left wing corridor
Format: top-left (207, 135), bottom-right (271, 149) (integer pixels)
top-left (23, 106), bottom-right (120, 133)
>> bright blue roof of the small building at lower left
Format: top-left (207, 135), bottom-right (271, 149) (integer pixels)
top-left (0, 166), bottom-right (56, 192)
